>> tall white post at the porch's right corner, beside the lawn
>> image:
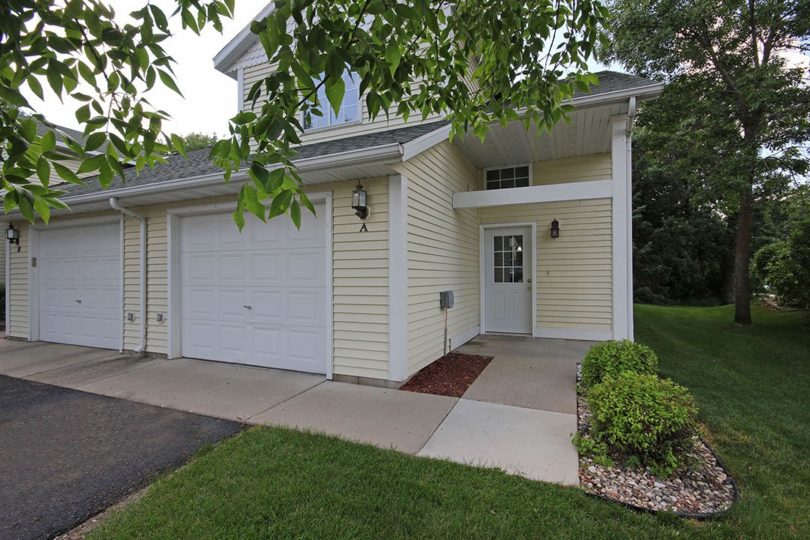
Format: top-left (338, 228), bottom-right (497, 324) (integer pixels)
top-left (611, 116), bottom-right (633, 339)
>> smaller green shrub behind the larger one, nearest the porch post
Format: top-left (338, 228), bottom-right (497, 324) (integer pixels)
top-left (582, 340), bottom-right (658, 389)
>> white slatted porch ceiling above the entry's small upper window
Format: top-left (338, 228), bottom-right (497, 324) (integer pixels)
top-left (455, 103), bottom-right (627, 168)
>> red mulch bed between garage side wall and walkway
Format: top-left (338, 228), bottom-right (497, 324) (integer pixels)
top-left (399, 353), bottom-right (492, 397)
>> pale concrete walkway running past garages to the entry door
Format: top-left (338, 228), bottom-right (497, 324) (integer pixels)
top-left (0, 336), bottom-right (590, 485)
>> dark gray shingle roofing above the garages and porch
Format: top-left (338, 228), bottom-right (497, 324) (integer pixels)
top-left (55, 71), bottom-right (655, 197)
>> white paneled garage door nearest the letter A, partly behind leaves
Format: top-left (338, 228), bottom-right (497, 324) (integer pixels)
top-left (180, 206), bottom-right (329, 373)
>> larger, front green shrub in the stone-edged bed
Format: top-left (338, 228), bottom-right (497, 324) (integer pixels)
top-left (587, 372), bottom-right (697, 476)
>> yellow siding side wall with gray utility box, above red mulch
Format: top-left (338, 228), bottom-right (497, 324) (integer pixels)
top-left (398, 141), bottom-right (480, 375)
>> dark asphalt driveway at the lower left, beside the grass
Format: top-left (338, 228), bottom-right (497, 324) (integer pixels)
top-left (0, 374), bottom-right (242, 539)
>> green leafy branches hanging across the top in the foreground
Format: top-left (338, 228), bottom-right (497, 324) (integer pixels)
top-left (0, 0), bottom-right (607, 227)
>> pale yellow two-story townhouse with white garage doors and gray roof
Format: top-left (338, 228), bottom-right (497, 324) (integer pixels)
top-left (5, 2), bottom-right (662, 386)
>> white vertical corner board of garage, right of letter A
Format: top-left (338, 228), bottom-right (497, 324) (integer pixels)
top-left (388, 175), bottom-right (408, 381)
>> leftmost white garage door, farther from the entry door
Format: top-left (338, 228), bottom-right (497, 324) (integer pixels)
top-left (37, 222), bottom-right (122, 349)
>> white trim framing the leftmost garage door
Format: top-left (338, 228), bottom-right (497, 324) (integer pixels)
top-left (28, 214), bottom-right (124, 348)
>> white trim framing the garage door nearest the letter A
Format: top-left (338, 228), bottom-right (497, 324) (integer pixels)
top-left (166, 191), bottom-right (334, 380)
